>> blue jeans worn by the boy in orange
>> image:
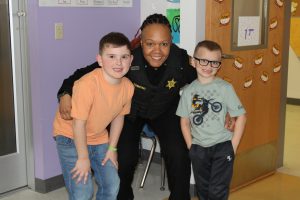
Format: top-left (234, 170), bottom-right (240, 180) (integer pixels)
top-left (55, 136), bottom-right (120, 200)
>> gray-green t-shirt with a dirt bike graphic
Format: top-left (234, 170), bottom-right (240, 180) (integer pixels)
top-left (176, 77), bottom-right (246, 147)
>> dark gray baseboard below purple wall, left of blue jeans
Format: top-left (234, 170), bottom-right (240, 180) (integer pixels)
top-left (35, 175), bottom-right (65, 193)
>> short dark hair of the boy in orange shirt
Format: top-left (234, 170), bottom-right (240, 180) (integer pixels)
top-left (99, 32), bottom-right (131, 54)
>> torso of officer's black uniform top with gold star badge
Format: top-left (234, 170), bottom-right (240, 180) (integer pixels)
top-left (127, 44), bottom-right (196, 119)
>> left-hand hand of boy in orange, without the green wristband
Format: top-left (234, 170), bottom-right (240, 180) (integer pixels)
top-left (71, 158), bottom-right (91, 184)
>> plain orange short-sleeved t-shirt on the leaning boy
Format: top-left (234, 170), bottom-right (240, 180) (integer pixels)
top-left (53, 68), bottom-right (134, 145)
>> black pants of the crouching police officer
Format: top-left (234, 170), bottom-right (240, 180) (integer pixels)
top-left (118, 105), bottom-right (191, 200)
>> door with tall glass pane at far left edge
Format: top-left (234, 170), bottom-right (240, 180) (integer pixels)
top-left (0, 0), bottom-right (27, 194)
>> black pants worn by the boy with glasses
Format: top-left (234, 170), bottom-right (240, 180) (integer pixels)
top-left (190, 141), bottom-right (234, 200)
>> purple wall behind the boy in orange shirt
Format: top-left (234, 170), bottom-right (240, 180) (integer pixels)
top-left (28, 0), bottom-right (140, 180)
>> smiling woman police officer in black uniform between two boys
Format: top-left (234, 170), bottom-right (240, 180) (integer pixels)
top-left (58, 14), bottom-right (196, 200)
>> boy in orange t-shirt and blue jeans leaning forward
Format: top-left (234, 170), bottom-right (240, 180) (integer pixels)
top-left (53, 32), bottom-right (134, 200)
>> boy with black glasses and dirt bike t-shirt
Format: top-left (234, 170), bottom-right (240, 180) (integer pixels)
top-left (176, 40), bottom-right (246, 200)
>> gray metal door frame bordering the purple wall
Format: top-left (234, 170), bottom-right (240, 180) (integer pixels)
top-left (9, 0), bottom-right (35, 190)
